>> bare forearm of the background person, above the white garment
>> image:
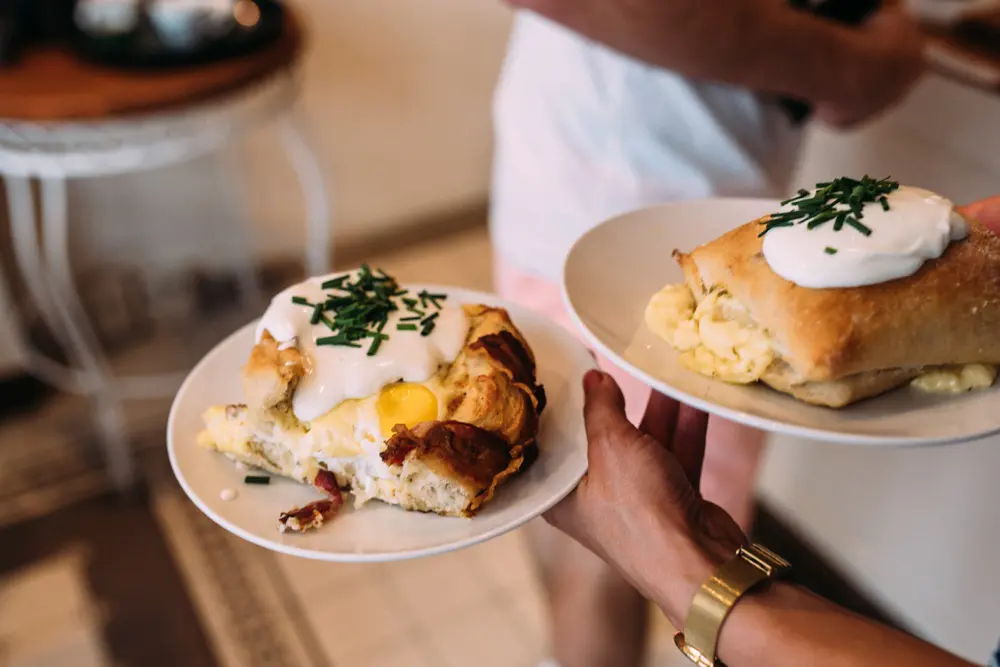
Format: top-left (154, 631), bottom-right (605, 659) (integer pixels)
top-left (511, 0), bottom-right (861, 103)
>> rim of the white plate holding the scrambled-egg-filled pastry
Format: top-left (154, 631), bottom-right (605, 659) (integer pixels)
top-left (560, 197), bottom-right (1000, 448)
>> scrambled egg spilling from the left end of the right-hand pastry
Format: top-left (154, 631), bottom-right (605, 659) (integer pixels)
top-left (646, 285), bottom-right (775, 384)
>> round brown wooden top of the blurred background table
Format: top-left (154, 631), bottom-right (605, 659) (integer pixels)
top-left (0, 6), bottom-right (304, 122)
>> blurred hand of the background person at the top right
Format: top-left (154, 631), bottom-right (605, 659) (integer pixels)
top-left (816, 7), bottom-right (926, 127)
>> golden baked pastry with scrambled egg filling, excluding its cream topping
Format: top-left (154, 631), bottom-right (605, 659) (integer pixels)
top-left (646, 180), bottom-right (1000, 407)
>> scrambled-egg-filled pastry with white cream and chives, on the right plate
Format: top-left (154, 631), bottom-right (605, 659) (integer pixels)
top-left (645, 176), bottom-right (1000, 408)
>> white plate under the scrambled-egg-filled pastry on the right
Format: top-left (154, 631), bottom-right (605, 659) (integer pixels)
top-left (563, 199), bottom-right (1000, 445)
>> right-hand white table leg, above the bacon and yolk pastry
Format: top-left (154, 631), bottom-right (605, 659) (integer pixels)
top-left (278, 110), bottom-right (333, 276)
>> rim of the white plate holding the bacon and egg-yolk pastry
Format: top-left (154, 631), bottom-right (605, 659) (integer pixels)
top-left (166, 284), bottom-right (596, 563)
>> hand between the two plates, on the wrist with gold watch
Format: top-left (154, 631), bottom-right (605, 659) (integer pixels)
top-left (546, 371), bottom-right (746, 627)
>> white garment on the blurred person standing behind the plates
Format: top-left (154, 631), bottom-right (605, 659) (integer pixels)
top-left (490, 12), bottom-right (801, 281)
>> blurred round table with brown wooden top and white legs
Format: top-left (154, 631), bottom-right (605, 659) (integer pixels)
top-left (0, 11), bottom-right (332, 490)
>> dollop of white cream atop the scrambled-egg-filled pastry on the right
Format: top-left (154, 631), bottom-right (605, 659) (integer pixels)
top-left (763, 186), bottom-right (969, 289)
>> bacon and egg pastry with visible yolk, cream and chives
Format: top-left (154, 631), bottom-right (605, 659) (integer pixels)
top-left (200, 267), bottom-right (545, 531)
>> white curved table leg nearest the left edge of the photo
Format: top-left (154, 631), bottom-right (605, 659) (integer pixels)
top-left (6, 177), bottom-right (135, 492)
